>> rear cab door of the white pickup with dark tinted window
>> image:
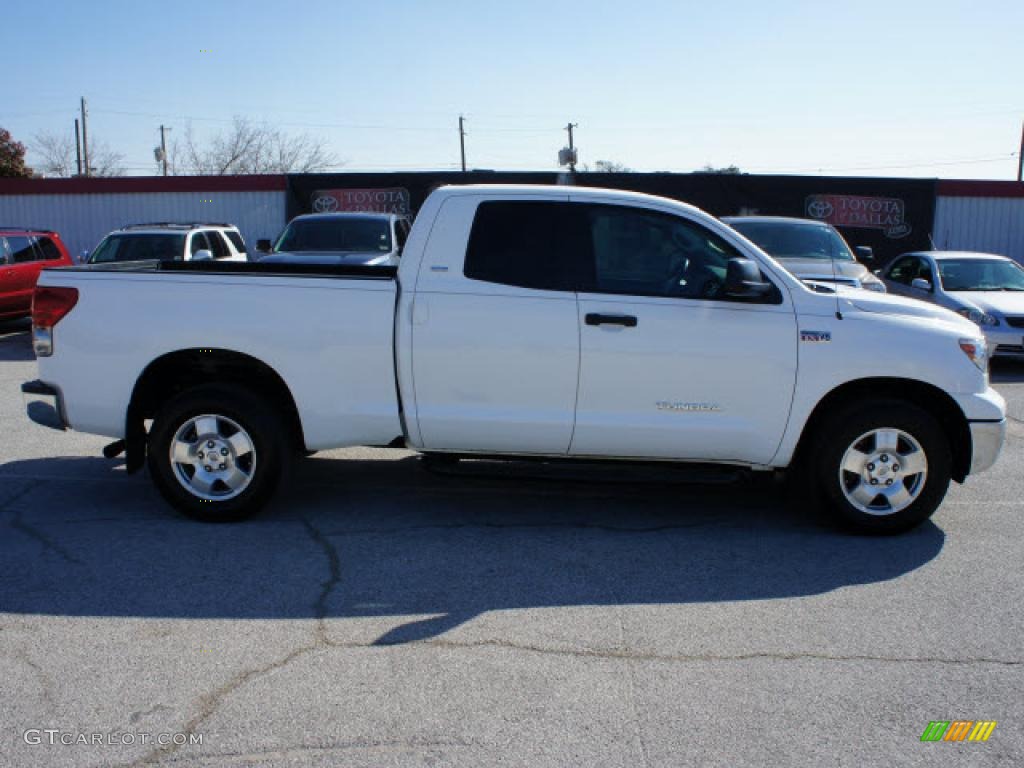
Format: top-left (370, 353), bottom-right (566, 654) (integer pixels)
top-left (407, 191), bottom-right (580, 455)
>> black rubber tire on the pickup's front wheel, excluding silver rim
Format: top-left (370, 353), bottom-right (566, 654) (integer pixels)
top-left (798, 399), bottom-right (952, 535)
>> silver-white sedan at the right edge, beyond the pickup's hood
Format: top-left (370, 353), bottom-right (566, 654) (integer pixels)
top-left (879, 251), bottom-right (1024, 358)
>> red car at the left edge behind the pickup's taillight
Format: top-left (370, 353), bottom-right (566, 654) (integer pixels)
top-left (0, 227), bottom-right (73, 318)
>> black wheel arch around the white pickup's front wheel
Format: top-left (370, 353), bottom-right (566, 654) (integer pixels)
top-left (796, 377), bottom-right (973, 482)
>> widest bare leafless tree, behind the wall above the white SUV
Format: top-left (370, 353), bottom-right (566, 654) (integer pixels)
top-left (177, 116), bottom-right (338, 176)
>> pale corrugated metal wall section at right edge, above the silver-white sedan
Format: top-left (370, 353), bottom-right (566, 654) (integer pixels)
top-left (932, 195), bottom-right (1024, 263)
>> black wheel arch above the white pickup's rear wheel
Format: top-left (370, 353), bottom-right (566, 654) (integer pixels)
top-left (125, 348), bottom-right (305, 472)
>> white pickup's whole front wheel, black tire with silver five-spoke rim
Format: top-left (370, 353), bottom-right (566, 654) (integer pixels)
top-left (812, 400), bottom-right (951, 534)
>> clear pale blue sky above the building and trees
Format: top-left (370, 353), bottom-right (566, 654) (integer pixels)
top-left (0, 0), bottom-right (1024, 178)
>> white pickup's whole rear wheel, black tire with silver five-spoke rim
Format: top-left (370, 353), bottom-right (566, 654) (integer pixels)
top-left (147, 386), bottom-right (288, 522)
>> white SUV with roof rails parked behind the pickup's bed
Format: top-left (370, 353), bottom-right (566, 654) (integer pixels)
top-left (86, 223), bottom-right (248, 264)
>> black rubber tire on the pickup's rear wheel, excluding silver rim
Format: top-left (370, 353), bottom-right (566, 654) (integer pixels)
top-left (146, 385), bottom-right (290, 522)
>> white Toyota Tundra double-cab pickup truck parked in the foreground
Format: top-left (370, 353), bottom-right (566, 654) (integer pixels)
top-left (23, 186), bottom-right (1006, 532)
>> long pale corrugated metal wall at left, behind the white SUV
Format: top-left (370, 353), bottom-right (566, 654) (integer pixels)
top-left (0, 191), bottom-right (286, 257)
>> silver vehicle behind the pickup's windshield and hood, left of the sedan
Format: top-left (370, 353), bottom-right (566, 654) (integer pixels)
top-left (722, 216), bottom-right (886, 293)
